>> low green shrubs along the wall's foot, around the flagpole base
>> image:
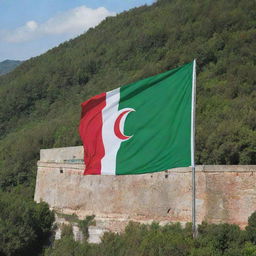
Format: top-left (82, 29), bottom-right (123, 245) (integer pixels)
top-left (45, 213), bottom-right (256, 256)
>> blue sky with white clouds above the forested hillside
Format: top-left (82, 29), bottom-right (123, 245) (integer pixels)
top-left (0, 0), bottom-right (155, 62)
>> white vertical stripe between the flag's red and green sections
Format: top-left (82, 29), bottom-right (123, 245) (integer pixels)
top-left (101, 88), bottom-right (122, 175)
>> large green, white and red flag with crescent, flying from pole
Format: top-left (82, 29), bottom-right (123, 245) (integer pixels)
top-left (79, 63), bottom-right (193, 175)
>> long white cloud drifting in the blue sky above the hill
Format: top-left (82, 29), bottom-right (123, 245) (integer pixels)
top-left (0, 5), bottom-right (115, 43)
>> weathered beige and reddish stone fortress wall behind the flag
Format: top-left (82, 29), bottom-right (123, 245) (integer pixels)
top-left (35, 147), bottom-right (256, 231)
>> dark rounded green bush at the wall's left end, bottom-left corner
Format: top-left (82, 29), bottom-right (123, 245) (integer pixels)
top-left (0, 193), bottom-right (54, 256)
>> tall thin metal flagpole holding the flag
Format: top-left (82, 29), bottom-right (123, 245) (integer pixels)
top-left (191, 59), bottom-right (197, 238)
